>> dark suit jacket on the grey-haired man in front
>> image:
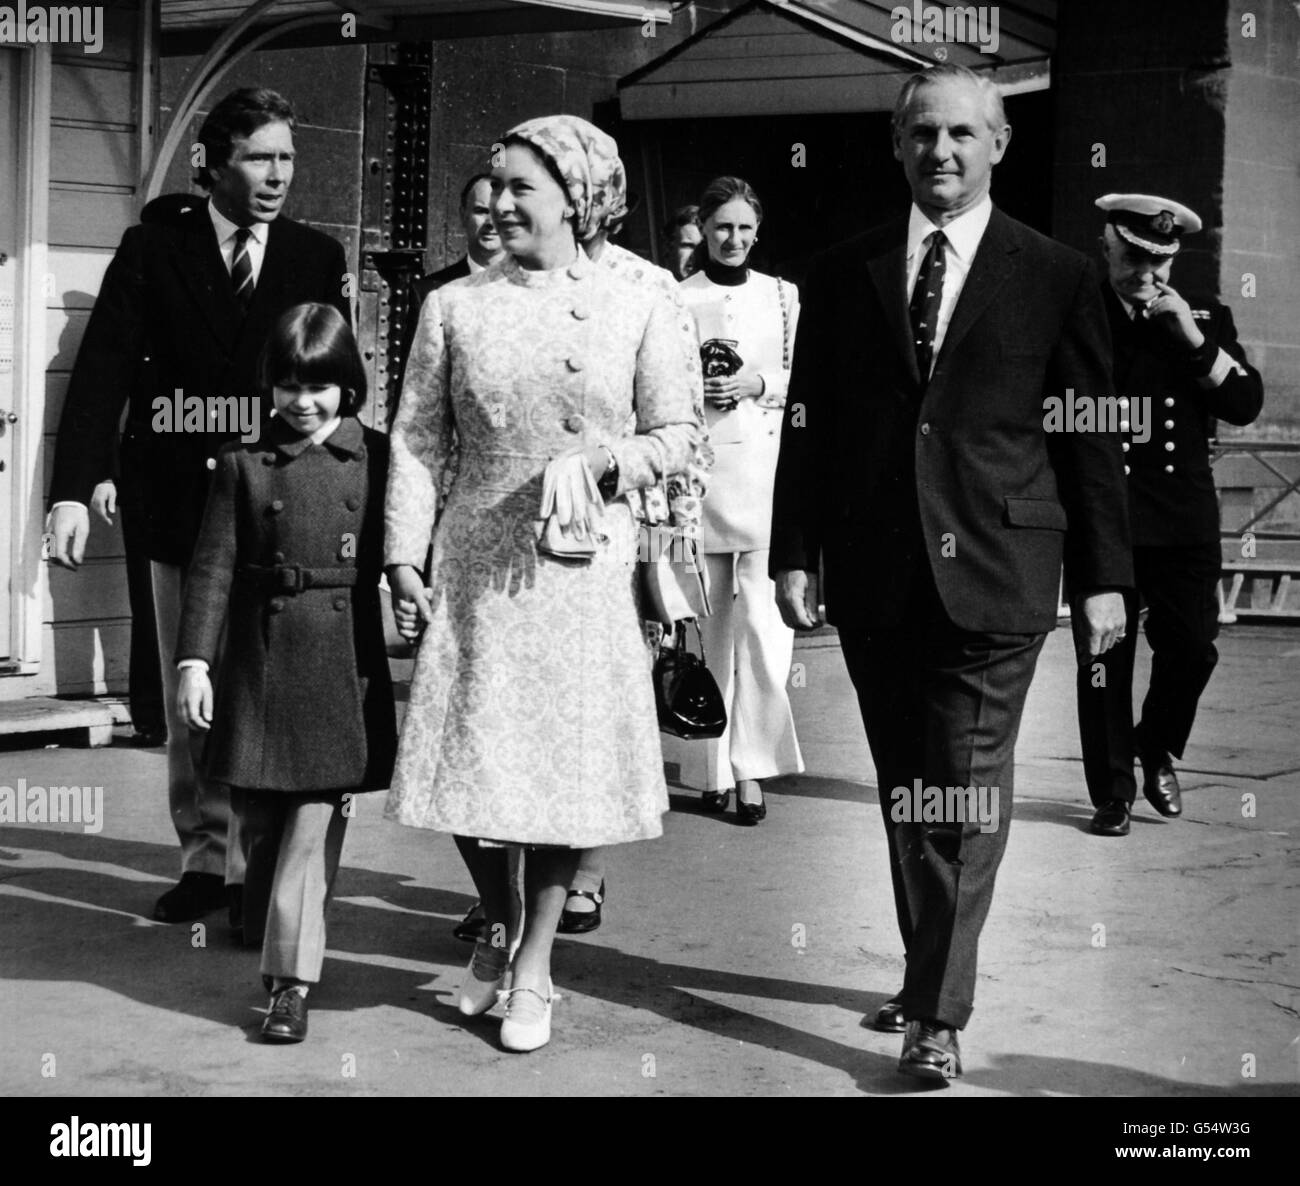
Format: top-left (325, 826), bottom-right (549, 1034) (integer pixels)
top-left (770, 208), bottom-right (1132, 633)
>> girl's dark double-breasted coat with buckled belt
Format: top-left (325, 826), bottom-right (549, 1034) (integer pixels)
top-left (176, 417), bottom-right (397, 791)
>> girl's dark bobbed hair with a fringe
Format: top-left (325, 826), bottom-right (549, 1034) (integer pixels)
top-left (257, 304), bottom-right (365, 416)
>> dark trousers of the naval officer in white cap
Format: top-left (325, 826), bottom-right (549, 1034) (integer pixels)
top-left (1071, 541), bottom-right (1222, 808)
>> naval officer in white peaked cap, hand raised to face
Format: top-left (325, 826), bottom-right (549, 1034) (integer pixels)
top-left (1075, 194), bottom-right (1264, 836)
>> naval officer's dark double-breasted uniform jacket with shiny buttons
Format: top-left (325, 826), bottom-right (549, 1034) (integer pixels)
top-left (1102, 283), bottom-right (1264, 547)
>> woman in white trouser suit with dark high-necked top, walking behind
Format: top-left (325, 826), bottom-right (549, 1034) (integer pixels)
top-left (675, 177), bottom-right (803, 824)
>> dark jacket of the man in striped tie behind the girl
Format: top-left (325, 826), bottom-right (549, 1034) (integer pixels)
top-left (49, 200), bottom-right (351, 566)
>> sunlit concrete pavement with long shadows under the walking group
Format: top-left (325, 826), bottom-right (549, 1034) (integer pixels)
top-left (0, 627), bottom-right (1300, 1099)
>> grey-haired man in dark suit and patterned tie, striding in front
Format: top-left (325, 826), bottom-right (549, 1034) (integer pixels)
top-left (771, 65), bottom-right (1132, 1079)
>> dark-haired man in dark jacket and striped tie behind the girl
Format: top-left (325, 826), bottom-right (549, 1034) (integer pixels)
top-left (49, 90), bottom-right (351, 929)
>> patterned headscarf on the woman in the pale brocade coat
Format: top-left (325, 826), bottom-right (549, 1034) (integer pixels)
top-left (506, 116), bottom-right (628, 243)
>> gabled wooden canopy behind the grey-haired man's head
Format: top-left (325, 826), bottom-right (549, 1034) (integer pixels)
top-left (619, 0), bottom-right (1056, 120)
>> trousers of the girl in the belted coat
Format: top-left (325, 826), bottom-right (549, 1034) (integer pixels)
top-left (231, 788), bottom-right (347, 984)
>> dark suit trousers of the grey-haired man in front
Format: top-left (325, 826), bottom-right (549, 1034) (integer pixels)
top-left (840, 572), bottom-right (1047, 1029)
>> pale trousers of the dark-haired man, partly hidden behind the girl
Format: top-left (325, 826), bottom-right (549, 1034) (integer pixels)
top-left (152, 560), bottom-right (244, 886)
